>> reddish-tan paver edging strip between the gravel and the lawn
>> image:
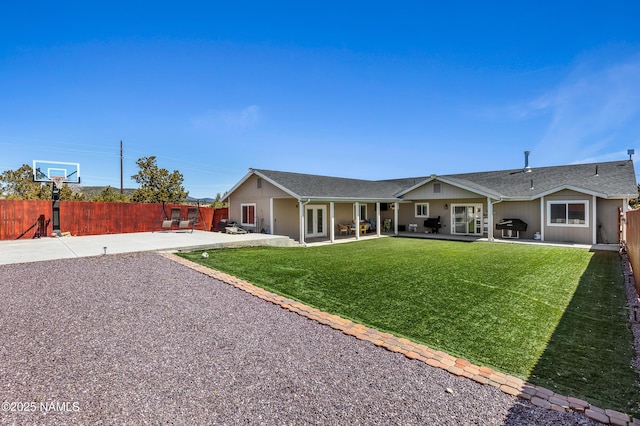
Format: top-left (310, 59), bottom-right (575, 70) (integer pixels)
top-left (162, 253), bottom-right (640, 426)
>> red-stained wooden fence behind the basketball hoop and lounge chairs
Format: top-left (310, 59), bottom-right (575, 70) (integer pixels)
top-left (0, 200), bottom-right (228, 240)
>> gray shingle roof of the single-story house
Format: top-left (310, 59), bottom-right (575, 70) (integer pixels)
top-left (253, 160), bottom-right (638, 202)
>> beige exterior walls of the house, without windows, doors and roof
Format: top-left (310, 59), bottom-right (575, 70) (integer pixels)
top-left (229, 175), bottom-right (622, 244)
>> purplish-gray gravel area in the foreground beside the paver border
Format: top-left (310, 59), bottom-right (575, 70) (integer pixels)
top-left (0, 253), bottom-right (597, 425)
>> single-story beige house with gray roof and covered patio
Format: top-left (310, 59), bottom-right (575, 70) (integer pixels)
top-left (224, 153), bottom-right (638, 244)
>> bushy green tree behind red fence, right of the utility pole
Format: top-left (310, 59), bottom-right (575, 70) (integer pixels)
top-left (131, 155), bottom-right (189, 203)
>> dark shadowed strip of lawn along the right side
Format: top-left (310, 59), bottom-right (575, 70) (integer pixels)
top-left (504, 251), bottom-right (640, 417)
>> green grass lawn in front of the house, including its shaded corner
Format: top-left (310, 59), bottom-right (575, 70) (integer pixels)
top-left (183, 238), bottom-right (640, 414)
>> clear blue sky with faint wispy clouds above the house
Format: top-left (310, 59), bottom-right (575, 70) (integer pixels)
top-left (0, 0), bottom-right (640, 198)
